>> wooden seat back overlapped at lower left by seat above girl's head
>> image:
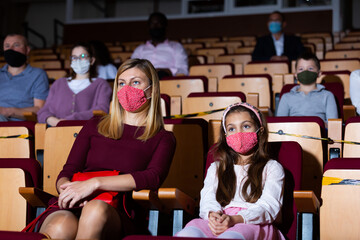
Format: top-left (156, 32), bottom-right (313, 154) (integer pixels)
top-left (219, 74), bottom-right (272, 108)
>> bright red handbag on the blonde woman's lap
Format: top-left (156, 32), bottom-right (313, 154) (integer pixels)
top-left (71, 170), bottom-right (120, 208)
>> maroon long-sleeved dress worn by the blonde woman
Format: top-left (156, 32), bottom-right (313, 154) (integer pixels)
top-left (40, 117), bottom-right (176, 233)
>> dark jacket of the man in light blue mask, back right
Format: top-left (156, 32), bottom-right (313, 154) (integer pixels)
top-left (252, 35), bottom-right (304, 61)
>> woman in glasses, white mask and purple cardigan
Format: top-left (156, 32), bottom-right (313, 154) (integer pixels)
top-left (38, 43), bottom-right (112, 126)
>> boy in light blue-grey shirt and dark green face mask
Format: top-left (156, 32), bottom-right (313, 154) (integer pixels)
top-left (277, 53), bottom-right (338, 123)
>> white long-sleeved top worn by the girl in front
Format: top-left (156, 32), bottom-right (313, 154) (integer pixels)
top-left (200, 160), bottom-right (285, 224)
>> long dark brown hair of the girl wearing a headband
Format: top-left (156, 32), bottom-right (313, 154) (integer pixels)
top-left (214, 106), bottom-right (269, 207)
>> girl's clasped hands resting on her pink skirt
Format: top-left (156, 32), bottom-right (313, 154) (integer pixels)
top-left (209, 211), bottom-right (244, 236)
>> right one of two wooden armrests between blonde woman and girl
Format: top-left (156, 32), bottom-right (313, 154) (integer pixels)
top-left (158, 188), bottom-right (195, 215)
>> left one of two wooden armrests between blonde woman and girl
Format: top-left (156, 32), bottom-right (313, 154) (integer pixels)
top-left (132, 189), bottom-right (169, 212)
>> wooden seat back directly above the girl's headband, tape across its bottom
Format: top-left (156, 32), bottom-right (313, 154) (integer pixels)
top-left (183, 92), bottom-right (246, 121)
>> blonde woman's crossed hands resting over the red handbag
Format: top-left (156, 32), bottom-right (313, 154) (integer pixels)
top-left (58, 178), bottom-right (99, 209)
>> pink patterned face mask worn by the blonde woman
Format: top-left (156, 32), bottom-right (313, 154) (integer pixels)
top-left (117, 85), bottom-right (151, 112)
